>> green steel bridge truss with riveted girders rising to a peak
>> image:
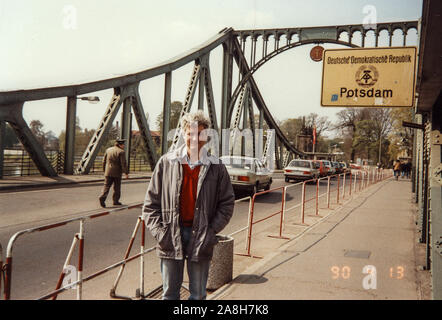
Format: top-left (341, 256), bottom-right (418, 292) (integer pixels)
top-left (0, 21), bottom-right (418, 178)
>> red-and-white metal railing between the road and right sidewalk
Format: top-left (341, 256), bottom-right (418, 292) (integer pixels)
top-left (0, 169), bottom-right (393, 300)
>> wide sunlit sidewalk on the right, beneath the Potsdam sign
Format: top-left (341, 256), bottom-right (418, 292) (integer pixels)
top-left (209, 179), bottom-right (431, 300)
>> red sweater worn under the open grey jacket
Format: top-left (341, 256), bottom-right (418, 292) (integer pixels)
top-left (180, 163), bottom-right (201, 227)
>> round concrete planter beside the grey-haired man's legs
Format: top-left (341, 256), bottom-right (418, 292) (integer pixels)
top-left (207, 235), bottom-right (233, 290)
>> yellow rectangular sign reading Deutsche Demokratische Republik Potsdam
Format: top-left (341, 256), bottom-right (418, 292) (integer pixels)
top-left (321, 47), bottom-right (416, 107)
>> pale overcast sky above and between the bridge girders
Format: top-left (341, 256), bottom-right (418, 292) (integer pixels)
top-left (0, 0), bottom-right (422, 135)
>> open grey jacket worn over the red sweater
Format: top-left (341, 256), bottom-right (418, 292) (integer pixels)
top-left (143, 145), bottom-right (235, 261)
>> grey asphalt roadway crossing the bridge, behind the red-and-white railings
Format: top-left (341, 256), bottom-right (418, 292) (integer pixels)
top-left (0, 174), bottom-right (348, 299)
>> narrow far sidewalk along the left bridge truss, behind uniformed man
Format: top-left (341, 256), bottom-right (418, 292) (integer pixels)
top-left (0, 172), bottom-right (151, 192)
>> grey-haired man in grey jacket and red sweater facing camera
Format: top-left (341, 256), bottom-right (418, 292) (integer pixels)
top-left (143, 111), bottom-right (235, 300)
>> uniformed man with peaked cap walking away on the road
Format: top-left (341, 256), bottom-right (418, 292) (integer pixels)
top-left (99, 139), bottom-right (129, 208)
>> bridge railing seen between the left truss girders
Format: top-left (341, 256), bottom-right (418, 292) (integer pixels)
top-left (3, 149), bottom-right (150, 177)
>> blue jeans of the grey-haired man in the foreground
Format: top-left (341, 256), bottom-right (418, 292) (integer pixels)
top-left (160, 227), bottom-right (210, 300)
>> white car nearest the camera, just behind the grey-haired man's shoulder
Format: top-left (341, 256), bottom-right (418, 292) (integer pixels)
top-left (220, 156), bottom-right (272, 195)
